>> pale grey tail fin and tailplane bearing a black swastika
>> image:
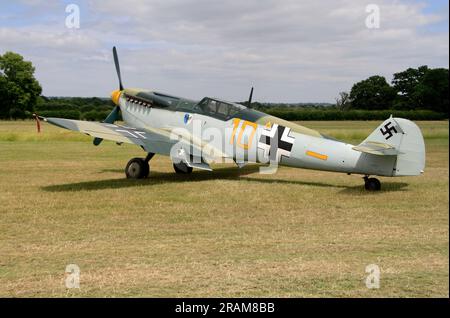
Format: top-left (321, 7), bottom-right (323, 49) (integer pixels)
top-left (353, 116), bottom-right (425, 176)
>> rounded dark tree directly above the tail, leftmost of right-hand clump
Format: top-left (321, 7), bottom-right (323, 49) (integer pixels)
top-left (350, 76), bottom-right (396, 110)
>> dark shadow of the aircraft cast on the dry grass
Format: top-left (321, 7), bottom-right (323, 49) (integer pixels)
top-left (41, 165), bottom-right (407, 194)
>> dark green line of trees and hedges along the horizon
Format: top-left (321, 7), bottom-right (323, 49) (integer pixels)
top-left (0, 52), bottom-right (449, 121)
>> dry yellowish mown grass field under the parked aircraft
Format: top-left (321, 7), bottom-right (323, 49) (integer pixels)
top-left (0, 122), bottom-right (449, 297)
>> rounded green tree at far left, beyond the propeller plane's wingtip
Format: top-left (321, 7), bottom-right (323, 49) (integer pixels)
top-left (0, 52), bottom-right (42, 118)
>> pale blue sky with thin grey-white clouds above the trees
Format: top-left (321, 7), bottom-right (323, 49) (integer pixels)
top-left (0, 0), bottom-right (449, 103)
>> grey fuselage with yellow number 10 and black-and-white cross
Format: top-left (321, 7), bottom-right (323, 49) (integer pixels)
top-left (117, 89), bottom-right (395, 176)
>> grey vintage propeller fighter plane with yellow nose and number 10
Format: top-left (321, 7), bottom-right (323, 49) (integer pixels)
top-left (37, 47), bottom-right (425, 191)
